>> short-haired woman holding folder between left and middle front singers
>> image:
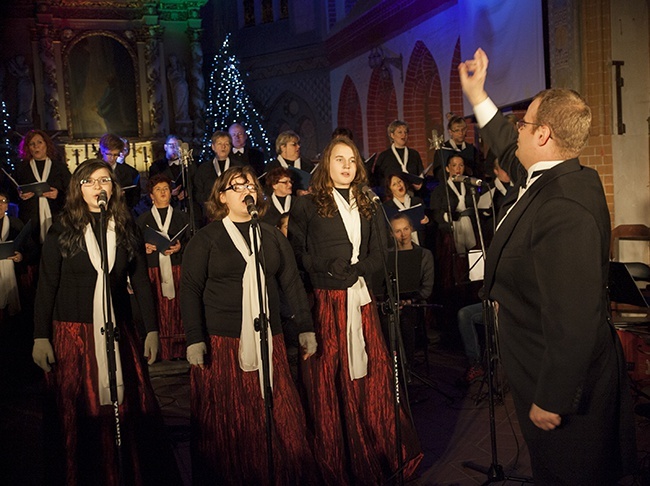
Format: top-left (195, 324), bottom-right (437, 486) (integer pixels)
top-left (138, 174), bottom-right (189, 359)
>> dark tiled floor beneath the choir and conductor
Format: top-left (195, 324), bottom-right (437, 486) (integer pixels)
top-left (0, 336), bottom-right (650, 486)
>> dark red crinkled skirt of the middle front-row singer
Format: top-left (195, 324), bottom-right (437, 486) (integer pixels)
top-left (191, 334), bottom-right (320, 485)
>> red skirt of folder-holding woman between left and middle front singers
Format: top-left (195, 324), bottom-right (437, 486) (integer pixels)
top-left (149, 265), bottom-right (185, 359)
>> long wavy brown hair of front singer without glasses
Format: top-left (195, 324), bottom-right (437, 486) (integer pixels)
top-left (310, 136), bottom-right (372, 220)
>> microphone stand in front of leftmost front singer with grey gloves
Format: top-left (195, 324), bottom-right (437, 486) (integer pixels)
top-left (99, 205), bottom-right (124, 484)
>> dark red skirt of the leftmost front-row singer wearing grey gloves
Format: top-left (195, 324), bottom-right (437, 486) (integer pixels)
top-left (44, 321), bottom-right (181, 486)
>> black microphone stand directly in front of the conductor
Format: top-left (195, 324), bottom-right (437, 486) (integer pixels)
top-left (463, 183), bottom-right (533, 485)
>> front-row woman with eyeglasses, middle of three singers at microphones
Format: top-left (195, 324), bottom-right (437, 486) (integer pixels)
top-left (181, 166), bottom-right (318, 485)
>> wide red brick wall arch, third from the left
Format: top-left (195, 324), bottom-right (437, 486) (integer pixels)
top-left (404, 41), bottom-right (444, 165)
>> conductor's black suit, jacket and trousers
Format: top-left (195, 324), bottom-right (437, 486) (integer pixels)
top-left (481, 109), bottom-right (635, 484)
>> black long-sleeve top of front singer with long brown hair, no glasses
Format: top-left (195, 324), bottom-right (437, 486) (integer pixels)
top-left (289, 194), bottom-right (386, 290)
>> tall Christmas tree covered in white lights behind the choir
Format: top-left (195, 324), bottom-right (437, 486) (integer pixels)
top-left (201, 34), bottom-right (271, 160)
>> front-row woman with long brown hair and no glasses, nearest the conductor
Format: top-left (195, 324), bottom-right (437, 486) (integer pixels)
top-left (289, 137), bottom-right (422, 485)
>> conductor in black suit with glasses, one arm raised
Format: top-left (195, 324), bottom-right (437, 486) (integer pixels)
top-left (459, 49), bottom-right (636, 486)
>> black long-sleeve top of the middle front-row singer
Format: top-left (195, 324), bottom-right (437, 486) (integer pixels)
top-left (180, 221), bottom-right (314, 345)
